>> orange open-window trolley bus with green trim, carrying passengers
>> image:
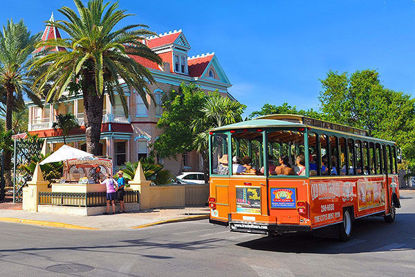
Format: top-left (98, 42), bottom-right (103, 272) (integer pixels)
top-left (209, 115), bottom-right (400, 240)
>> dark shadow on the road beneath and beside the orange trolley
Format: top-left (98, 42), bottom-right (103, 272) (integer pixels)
top-left (237, 213), bottom-right (415, 254)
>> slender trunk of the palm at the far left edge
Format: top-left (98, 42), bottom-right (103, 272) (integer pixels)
top-left (0, 85), bottom-right (14, 201)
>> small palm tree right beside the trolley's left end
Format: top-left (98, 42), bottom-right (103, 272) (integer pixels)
top-left (193, 93), bottom-right (246, 177)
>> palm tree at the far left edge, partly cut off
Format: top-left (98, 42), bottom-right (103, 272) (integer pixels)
top-left (0, 20), bottom-right (42, 186)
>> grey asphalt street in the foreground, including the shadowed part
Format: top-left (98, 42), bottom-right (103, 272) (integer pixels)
top-left (0, 191), bottom-right (415, 277)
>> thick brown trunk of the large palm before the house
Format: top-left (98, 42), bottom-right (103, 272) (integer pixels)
top-left (84, 92), bottom-right (104, 155)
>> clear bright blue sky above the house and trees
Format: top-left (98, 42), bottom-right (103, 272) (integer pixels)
top-left (0, 0), bottom-right (415, 114)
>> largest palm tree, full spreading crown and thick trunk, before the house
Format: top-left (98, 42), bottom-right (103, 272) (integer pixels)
top-left (33, 0), bottom-right (161, 155)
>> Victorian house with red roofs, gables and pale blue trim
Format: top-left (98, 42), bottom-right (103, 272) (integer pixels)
top-left (28, 16), bottom-right (232, 174)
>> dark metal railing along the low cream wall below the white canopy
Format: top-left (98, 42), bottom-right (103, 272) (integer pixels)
top-left (39, 191), bottom-right (139, 207)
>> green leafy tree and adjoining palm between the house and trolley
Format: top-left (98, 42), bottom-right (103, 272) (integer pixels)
top-left (154, 84), bottom-right (246, 172)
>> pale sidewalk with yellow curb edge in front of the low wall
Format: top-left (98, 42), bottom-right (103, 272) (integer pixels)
top-left (0, 205), bottom-right (209, 230)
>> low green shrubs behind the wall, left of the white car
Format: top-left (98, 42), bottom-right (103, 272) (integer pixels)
top-left (114, 157), bottom-right (171, 185)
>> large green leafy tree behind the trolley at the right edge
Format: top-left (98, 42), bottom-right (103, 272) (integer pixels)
top-left (319, 70), bottom-right (415, 167)
